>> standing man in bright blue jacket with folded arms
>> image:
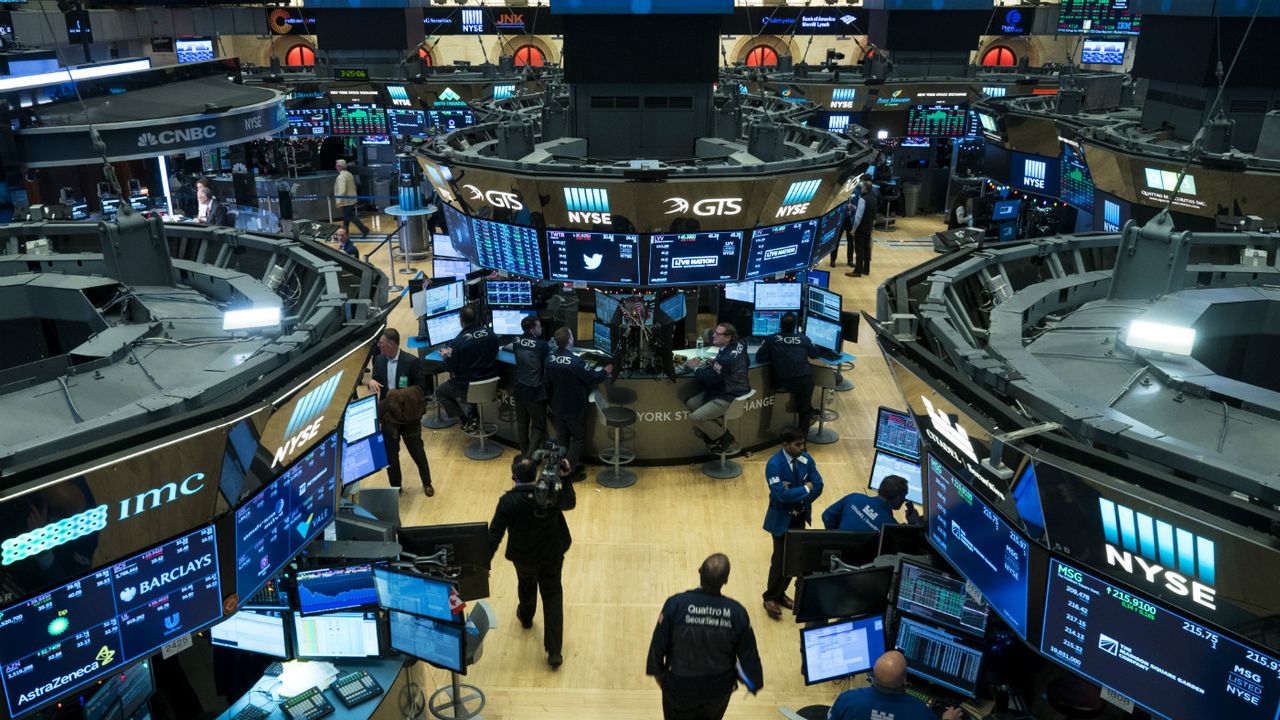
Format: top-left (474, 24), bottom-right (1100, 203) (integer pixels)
top-left (764, 428), bottom-right (822, 620)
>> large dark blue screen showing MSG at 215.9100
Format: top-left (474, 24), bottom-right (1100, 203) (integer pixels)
top-left (1041, 560), bottom-right (1280, 720)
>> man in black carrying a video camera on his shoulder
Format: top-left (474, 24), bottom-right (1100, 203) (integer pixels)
top-left (489, 455), bottom-right (577, 669)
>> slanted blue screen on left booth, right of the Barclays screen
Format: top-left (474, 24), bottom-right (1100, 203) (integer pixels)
top-left (236, 433), bottom-right (338, 598)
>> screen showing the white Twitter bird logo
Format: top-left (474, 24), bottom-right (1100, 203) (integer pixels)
top-left (547, 231), bottom-right (640, 284)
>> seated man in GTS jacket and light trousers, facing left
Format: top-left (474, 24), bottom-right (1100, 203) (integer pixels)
top-left (685, 323), bottom-right (751, 454)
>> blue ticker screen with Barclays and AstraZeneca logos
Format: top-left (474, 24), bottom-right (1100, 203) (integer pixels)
top-left (0, 527), bottom-right (223, 716)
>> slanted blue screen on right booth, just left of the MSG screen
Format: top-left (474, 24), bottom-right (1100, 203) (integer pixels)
top-left (925, 455), bottom-right (1030, 638)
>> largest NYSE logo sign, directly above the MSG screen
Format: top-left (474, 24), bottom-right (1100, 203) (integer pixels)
top-left (1098, 497), bottom-right (1217, 610)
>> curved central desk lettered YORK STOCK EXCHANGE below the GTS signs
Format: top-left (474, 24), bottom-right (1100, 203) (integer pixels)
top-left (426, 345), bottom-right (854, 465)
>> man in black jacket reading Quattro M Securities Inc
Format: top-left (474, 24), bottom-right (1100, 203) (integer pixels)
top-left (645, 552), bottom-right (764, 720)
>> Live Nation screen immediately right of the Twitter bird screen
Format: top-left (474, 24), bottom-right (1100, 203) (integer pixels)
top-left (649, 231), bottom-right (742, 284)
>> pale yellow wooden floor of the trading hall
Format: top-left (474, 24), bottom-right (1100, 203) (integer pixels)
top-left (348, 211), bottom-right (941, 720)
